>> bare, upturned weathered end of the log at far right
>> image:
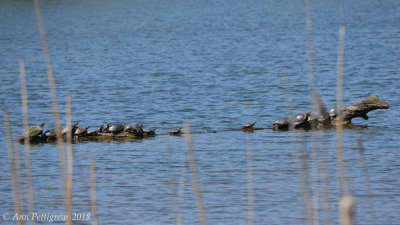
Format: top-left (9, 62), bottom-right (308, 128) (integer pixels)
top-left (332, 95), bottom-right (389, 125)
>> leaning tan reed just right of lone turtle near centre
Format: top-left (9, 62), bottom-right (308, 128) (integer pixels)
top-left (183, 122), bottom-right (207, 225)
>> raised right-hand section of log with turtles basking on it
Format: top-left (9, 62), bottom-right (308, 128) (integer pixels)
top-left (273, 95), bottom-right (389, 130)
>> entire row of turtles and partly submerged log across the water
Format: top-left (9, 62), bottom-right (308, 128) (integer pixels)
top-left (19, 96), bottom-right (389, 142)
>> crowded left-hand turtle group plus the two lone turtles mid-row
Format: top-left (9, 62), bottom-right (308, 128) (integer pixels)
top-left (19, 122), bottom-right (256, 142)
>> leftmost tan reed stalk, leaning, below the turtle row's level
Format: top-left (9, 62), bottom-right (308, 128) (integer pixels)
top-left (3, 107), bottom-right (25, 224)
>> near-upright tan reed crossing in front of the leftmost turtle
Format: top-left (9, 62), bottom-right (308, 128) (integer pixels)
top-left (19, 59), bottom-right (35, 225)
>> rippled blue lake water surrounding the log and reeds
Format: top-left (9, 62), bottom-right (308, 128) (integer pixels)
top-left (0, 0), bottom-right (400, 224)
